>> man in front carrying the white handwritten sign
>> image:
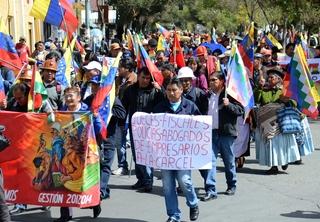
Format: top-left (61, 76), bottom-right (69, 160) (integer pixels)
top-left (154, 77), bottom-right (200, 222)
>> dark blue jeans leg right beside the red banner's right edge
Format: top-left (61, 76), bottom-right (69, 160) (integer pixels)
top-left (100, 134), bottom-right (116, 198)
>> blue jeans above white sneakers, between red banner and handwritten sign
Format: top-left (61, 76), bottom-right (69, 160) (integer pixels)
top-left (116, 124), bottom-right (128, 168)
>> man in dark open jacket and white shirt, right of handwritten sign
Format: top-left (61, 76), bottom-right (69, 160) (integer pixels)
top-left (201, 72), bottom-right (244, 201)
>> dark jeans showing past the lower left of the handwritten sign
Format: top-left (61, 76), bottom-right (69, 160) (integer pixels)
top-left (130, 129), bottom-right (153, 186)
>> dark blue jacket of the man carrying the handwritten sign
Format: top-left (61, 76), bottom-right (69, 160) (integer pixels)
top-left (153, 97), bottom-right (201, 115)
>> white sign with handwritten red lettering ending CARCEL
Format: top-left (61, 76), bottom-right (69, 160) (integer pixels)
top-left (131, 112), bottom-right (212, 170)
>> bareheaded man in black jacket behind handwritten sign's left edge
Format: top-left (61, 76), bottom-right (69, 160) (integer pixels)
top-left (122, 68), bottom-right (164, 192)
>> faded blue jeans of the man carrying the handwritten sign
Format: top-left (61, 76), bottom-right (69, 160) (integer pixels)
top-left (161, 170), bottom-right (199, 221)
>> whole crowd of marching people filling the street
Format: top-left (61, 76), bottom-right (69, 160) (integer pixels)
top-left (0, 23), bottom-right (314, 222)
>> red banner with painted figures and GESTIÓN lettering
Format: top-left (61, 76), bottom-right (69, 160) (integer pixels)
top-left (0, 111), bottom-right (100, 207)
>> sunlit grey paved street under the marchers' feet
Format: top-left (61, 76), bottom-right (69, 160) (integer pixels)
top-left (13, 120), bottom-right (320, 222)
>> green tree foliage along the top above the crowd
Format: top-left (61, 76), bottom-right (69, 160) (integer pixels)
top-left (109, 0), bottom-right (320, 32)
